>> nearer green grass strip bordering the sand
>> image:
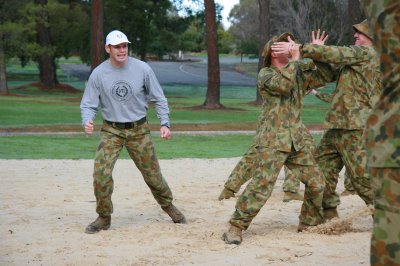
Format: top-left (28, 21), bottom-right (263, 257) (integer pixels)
top-left (0, 132), bottom-right (320, 159)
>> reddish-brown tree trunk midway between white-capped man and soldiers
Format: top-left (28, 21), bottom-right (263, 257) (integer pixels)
top-left (203, 0), bottom-right (223, 109)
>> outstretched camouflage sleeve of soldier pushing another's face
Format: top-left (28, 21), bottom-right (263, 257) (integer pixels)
top-left (300, 44), bottom-right (375, 65)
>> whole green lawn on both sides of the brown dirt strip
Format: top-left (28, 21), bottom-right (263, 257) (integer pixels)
top-left (0, 58), bottom-right (332, 159)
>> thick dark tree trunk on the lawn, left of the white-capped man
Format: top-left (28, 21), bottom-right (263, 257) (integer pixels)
top-left (35, 0), bottom-right (58, 89)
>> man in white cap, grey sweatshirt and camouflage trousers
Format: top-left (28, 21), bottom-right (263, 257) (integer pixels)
top-left (80, 31), bottom-right (186, 234)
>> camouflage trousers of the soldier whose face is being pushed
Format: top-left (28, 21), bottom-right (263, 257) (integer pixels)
top-left (229, 144), bottom-right (324, 230)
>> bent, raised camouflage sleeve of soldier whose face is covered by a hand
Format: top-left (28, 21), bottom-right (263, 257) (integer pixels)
top-left (257, 63), bottom-right (296, 95)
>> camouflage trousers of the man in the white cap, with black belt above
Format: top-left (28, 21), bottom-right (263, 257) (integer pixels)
top-left (93, 123), bottom-right (172, 216)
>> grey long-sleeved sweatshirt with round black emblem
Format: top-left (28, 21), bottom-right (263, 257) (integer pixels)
top-left (80, 57), bottom-right (169, 126)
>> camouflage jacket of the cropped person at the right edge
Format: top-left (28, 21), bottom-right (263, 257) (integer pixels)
top-left (364, 0), bottom-right (400, 166)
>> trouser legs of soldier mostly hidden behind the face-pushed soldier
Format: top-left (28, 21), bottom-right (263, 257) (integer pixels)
top-left (224, 144), bottom-right (300, 193)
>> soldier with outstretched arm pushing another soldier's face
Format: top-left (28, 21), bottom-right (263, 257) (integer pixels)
top-left (272, 21), bottom-right (381, 219)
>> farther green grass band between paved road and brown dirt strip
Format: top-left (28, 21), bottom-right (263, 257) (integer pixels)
top-left (0, 85), bottom-right (328, 128)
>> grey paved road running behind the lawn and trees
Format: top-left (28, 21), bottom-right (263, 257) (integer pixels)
top-left (61, 58), bottom-right (256, 86)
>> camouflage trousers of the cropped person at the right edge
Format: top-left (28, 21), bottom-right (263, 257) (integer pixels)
top-left (370, 168), bottom-right (400, 266)
